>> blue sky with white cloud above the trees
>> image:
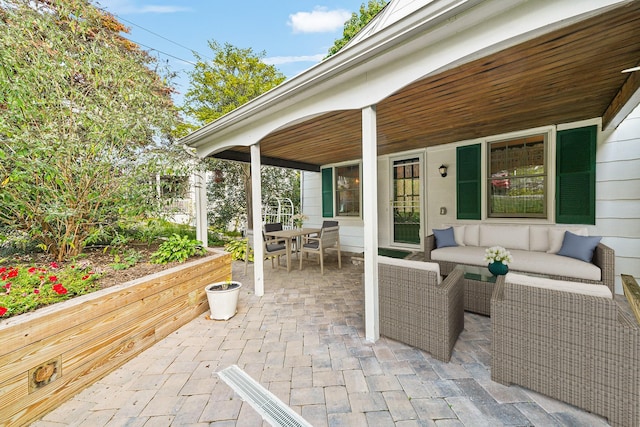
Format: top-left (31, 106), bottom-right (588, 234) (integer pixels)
top-left (93, 0), bottom-right (366, 104)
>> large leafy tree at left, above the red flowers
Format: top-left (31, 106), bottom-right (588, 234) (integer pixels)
top-left (0, 0), bottom-right (185, 260)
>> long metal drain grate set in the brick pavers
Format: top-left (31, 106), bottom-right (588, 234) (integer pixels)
top-left (218, 365), bottom-right (313, 427)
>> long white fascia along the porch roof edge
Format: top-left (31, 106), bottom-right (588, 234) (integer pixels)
top-left (181, 0), bottom-right (631, 157)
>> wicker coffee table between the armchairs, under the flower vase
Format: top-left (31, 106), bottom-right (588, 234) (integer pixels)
top-left (456, 265), bottom-right (496, 316)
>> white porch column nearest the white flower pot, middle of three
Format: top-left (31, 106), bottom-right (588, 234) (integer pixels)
top-left (251, 144), bottom-right (264, 297)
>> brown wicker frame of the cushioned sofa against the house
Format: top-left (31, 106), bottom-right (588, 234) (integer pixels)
top-left (424, 234), bottom-right (616, 294)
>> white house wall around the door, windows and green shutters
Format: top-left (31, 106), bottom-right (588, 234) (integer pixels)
top-left (303, 107), bottom-right (640, 293)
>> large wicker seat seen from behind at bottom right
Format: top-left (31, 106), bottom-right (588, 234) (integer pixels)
top-left (491, 276), bottom-right (640, 427)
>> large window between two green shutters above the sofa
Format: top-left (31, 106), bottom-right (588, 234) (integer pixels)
top-left (486, 134), bottom-right (547, 218)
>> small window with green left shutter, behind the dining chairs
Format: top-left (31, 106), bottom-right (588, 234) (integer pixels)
top-left (322, 164), bottom-right (360, 218)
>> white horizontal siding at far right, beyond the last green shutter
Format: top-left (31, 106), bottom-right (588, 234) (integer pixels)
top-left (596, 106), bottom-right (640, 293)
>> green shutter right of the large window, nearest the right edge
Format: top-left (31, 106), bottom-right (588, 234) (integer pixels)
top-left (556, 126), bottom-right (597, 224)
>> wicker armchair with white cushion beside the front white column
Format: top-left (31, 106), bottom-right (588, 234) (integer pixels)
top-left (378, 257), bottom-right (464, 362)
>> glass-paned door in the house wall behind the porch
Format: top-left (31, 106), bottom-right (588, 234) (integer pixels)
top-left (391, 157), bottom-right (421, 245)
